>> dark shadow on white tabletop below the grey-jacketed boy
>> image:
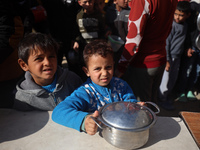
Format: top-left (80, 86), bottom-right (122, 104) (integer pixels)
top-left (0, 109), bottom-right (49, 143)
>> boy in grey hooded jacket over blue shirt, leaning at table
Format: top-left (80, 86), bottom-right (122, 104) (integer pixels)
top-left (14, 33), bottom-right (82, 110)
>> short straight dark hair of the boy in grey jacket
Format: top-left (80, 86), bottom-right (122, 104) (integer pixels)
top-left (18, 32), bottom-right (59, 64)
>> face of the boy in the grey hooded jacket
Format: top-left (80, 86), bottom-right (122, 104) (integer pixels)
top-left (18, 50), bottom-right (57, 86)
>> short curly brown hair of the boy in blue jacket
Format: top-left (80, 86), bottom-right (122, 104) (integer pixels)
top-left (83, 40), bottom-right (114, 67)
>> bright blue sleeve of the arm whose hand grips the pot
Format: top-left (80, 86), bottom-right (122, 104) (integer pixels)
top-left (52, 88), bottom-right (89, 131)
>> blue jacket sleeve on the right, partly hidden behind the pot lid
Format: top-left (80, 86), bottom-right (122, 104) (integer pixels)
top-left (120, 81), bottom-right (138, 102)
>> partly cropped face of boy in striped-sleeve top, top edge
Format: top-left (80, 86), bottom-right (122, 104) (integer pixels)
top-left (78, 0), bottom-right (94, 13)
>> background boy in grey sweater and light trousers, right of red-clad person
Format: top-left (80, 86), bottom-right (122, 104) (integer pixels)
top-left (159, 1), bottom-right (190, 110)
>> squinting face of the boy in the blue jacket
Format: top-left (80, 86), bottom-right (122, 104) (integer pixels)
top-left (84, 54), bottom-right (114, 86)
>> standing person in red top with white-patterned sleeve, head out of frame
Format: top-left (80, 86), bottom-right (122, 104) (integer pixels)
top-left (116, 0), bottom-right (178, 102)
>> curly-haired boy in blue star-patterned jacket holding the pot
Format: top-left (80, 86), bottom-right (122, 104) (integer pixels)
top-left (52, 40), bottom-right (144, 135)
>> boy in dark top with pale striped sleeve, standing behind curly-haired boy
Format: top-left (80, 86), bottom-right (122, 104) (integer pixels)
top-left (73, 0), bottom-right (105, 51)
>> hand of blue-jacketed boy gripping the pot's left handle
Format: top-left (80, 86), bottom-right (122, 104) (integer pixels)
top-left (85, 110), bottom-right (99, 135)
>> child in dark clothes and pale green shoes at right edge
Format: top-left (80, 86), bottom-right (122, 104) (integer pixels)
top-left (177, 2), bottom-right (200, 102)
